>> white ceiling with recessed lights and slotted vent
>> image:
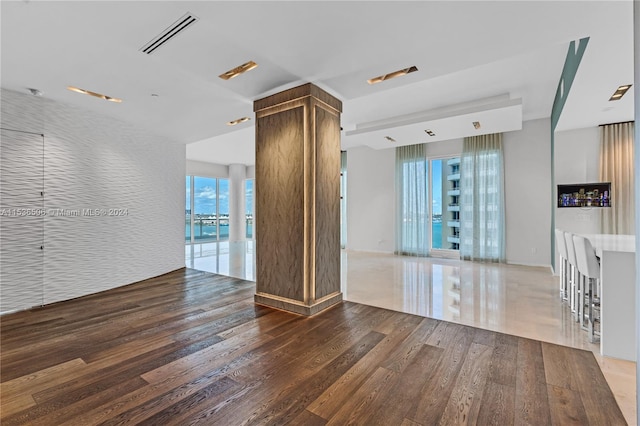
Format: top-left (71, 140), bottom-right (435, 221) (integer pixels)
top-left (0, 0), bottom-right (633, 164)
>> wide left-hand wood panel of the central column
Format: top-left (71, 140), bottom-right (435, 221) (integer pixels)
top-left (255, 106), bottom-right (304, 302)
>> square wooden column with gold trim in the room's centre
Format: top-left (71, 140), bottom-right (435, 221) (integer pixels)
top-left (253, 84), bottom-right (342, 315)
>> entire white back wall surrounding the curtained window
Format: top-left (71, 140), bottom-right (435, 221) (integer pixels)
top-left (347, 119), bottom-right (551, 266)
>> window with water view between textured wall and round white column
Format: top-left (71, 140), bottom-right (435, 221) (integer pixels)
top-left (185, 176), bottom-right (229, 242)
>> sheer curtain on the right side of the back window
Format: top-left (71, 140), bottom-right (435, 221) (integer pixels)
top-left (460, 133), bottom-right (505, 262)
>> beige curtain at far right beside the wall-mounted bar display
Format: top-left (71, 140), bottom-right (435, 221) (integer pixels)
top-left (600, 122), bottom-right (635, 234)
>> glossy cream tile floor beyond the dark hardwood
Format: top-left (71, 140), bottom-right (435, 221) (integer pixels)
top-left (185, 241), bottom-right (636, 424)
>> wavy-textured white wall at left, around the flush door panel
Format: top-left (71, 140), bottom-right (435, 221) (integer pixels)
top-left (0, 90), bottom-right (185, 311)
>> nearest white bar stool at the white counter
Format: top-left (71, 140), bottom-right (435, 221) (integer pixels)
top-left (573, 235), bottom-right (600, 342)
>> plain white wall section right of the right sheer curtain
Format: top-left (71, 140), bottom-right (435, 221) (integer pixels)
top-left (503, 119), bottom-right (552, 266)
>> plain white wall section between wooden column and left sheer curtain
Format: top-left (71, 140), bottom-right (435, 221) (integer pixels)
top-left (347, 147), bottom-right (396, 253)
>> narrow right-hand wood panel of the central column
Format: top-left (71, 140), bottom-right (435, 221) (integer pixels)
top-left (314, 104), bottom-right (340, 299)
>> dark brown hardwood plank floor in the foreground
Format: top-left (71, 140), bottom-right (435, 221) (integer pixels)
top-left (0, 269), bottom-right (626, 426)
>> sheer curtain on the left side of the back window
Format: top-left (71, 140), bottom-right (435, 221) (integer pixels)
top-left (396, 144), bottom-right (429, 256)
